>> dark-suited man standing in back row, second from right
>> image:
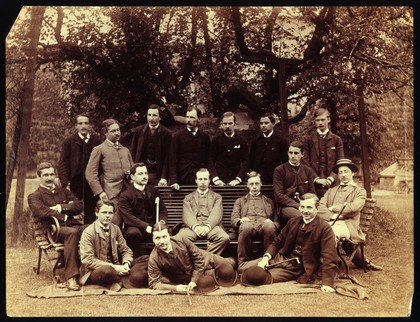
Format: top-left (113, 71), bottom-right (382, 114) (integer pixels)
top-left (249, 113), bottom-right (288, 185)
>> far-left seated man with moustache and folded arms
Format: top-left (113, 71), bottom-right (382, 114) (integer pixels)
top-left (28, 162), bottom-right (85, 291)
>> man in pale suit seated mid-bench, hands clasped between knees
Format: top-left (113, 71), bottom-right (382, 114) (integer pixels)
top-left (177, 168), bottom-right (229, 255)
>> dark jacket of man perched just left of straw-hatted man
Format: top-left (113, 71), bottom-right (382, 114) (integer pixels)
top-left (273, 161), bottom-right (315, 209)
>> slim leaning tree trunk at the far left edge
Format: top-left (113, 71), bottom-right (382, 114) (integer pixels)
top-left (12, 7), bottom-right (45, 245)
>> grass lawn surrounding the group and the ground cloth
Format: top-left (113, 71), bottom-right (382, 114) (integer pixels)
top-left (6, 181), bottom-right (414, 317)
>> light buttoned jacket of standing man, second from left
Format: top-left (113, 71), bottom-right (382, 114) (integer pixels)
top-left (86, 140), bottom-right (134, 199)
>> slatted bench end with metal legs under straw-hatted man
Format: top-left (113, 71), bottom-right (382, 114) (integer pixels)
top-left (337, 198), bottom-right (376, 276)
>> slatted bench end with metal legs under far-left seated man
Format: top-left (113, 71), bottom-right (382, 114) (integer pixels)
top-left (31, 215), bottom-right (65, 283)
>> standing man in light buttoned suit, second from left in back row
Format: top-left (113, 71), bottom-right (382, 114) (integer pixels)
top-left (85, 119), bottom-right (134, 226)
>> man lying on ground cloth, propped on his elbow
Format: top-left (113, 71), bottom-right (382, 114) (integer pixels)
top-left (148, 222), bottom-right (236, 294)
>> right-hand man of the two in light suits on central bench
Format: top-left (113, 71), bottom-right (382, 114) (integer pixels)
top-left (231, 171), bottom-right (280, 266)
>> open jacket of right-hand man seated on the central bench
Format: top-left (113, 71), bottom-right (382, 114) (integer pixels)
top-left (231, 193), bottom-right (280, 229)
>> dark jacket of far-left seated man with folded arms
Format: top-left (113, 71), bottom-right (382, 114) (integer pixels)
top-left (28, 186), bottom-right (83, 226)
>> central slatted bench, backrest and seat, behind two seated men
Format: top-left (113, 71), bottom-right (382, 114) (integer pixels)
top-left (150, 185), bottom-right (274, 257)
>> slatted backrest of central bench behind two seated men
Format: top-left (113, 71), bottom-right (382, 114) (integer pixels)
top-left (157, 185), bottom-right (274, 230)
